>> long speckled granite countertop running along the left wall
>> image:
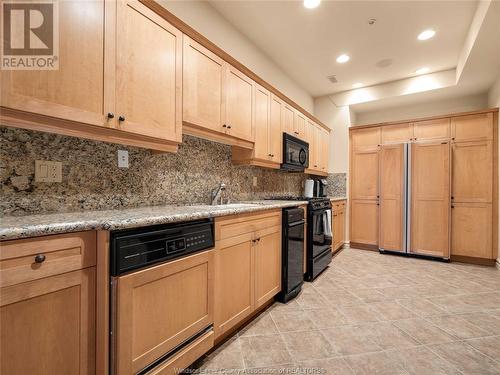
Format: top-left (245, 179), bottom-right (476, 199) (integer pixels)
top-left (0, 200), bottom-right (307, 240)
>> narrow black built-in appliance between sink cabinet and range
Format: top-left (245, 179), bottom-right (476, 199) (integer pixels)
top-left (278, 207), bottom-right (305, 303)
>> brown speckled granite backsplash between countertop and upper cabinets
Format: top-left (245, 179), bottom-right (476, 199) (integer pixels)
top-left (0, 127), bottom-right (312, 215)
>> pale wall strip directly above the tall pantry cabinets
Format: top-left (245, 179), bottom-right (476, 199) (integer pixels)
top-left (355, 93), bottom-right (488, 125)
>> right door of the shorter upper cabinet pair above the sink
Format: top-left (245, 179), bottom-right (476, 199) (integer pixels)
top-left (223, 65), bottom-right (254, 142)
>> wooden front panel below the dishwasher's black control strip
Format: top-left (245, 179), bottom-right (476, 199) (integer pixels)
top-left (115, 250), bottom-right (214, 374)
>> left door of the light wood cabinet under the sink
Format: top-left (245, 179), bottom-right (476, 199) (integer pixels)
top-left (214, 232), bottom-right (254, 337)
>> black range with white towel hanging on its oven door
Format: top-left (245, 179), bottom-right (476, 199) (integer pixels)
top-left (270, 196), bottom-right (333, 281)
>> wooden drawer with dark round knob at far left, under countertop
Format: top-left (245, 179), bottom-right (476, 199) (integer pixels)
top-left (0, 231), bottom-right (96, 287)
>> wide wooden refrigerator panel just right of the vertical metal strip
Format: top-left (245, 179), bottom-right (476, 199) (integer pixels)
top-left (410, 142), bottom-right (451, 258)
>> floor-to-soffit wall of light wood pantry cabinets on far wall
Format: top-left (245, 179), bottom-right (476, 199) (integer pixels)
top-left (350, 109), bottom-right (498, 262)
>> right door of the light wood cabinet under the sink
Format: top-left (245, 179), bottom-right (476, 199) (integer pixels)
top-left (255, 227), bottom-right (281, 308)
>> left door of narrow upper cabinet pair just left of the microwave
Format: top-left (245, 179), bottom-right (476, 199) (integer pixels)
top-left (254, 86), bottom-right (271, 160)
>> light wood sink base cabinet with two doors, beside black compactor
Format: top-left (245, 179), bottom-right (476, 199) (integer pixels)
top-left (214, 211), bottom-right (281, 338)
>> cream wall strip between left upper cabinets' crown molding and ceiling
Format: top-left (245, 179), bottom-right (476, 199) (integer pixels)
top-left (159, 0), bottom-right (314, 113)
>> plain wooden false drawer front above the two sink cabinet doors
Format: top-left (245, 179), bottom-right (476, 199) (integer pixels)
top-left (215, 210), bottom-right (281, 241)
